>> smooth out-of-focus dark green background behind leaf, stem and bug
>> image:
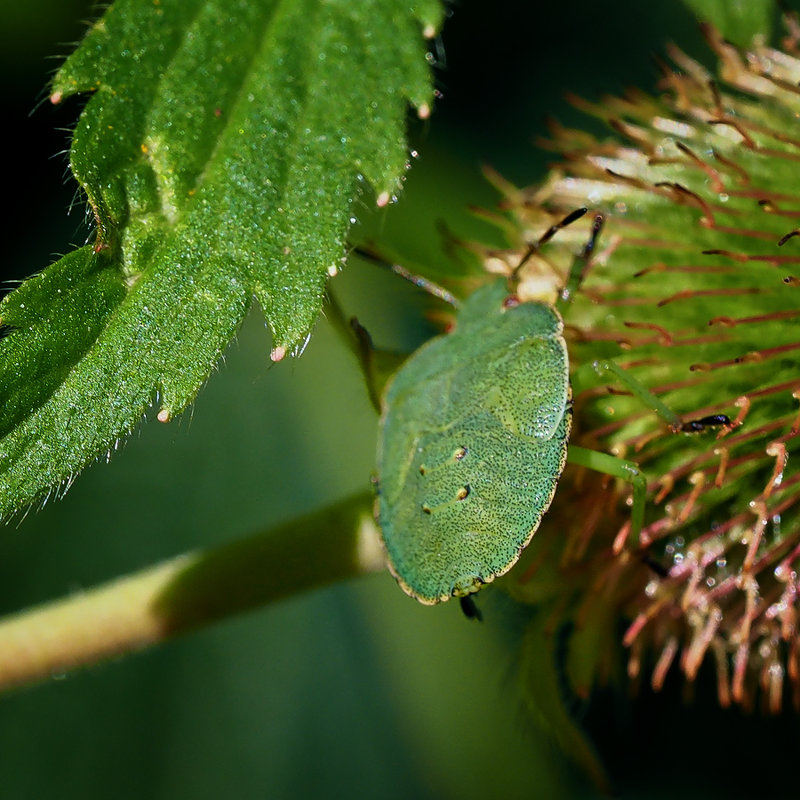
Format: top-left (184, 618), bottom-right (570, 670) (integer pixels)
top-left (0, 0), bottom-right (797, 800)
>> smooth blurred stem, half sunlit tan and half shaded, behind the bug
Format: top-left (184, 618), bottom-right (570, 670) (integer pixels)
top-left (0, 493), bottom-right (384, 691)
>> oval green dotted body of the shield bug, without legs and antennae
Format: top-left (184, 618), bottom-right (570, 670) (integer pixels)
top-left (378, 279), bottom-right (571, 604)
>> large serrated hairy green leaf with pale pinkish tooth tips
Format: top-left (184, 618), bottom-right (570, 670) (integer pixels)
top-left (0, 0), bottom-right (441, 515)
